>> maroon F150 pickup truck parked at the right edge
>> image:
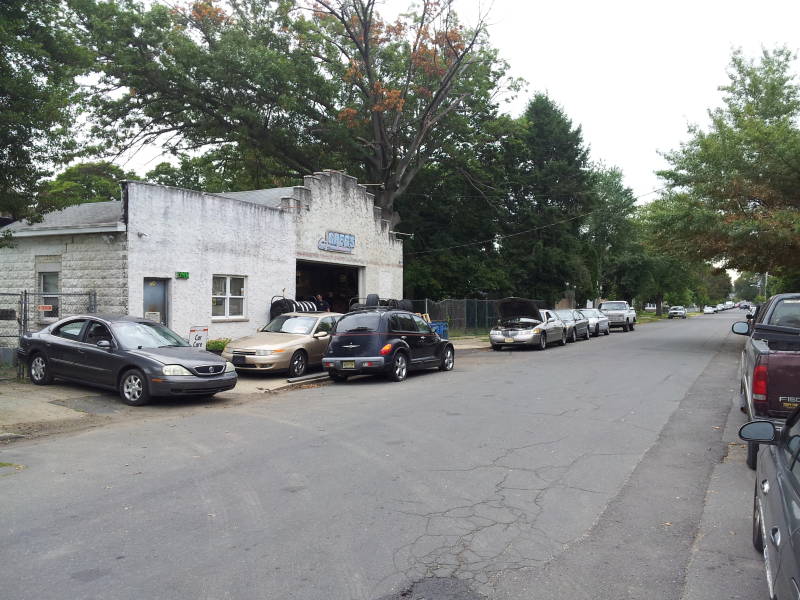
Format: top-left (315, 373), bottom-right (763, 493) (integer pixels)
top-left (731, 293), bottom-right (800, 469)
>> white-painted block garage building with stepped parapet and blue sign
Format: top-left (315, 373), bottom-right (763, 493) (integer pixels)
top-left (0, 171), bottom-right (403, 339)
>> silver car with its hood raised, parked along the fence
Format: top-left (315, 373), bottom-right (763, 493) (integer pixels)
top-left (489, 298), bottom-right (567, 350)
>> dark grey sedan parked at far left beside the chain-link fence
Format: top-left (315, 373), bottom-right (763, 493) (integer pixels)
top-left (18, 315), bottom-right (236, 406)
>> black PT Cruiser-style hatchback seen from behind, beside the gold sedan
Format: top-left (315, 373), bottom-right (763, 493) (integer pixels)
top-left (322, 308), bottom-right (455, 381)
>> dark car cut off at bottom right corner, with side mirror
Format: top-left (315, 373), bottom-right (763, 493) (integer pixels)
top-left (739, 409), bottom-right (800, 599)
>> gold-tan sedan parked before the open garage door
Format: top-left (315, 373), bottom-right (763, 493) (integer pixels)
top-left (222, 312), bottom-right (342, 377)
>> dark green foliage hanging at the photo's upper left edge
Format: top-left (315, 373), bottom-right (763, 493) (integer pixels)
top-left (0, 0), bottom-right (90, 220)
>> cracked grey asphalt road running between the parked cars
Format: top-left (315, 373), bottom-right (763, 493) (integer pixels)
top-left (0, 311), bottom-right (765, 600)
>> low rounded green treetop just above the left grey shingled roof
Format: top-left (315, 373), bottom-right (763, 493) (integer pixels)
top-left (38, 161), bottom-right (139, 210)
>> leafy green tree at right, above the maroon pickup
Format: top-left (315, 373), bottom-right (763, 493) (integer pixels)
top-left (654, 48), bottom-right (800, 271)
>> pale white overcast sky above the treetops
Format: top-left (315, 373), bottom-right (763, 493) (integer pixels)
top-left (125, 0), bottom-right (800, 201)
